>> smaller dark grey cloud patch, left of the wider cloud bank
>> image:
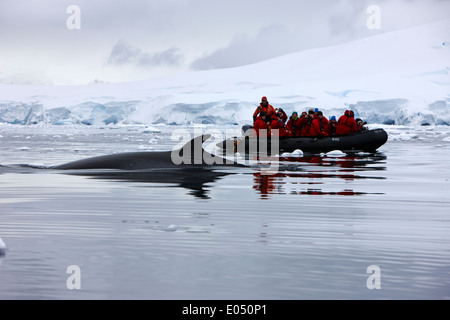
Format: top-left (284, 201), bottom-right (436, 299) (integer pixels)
top-left (108, 40), bottom-right (182, 67)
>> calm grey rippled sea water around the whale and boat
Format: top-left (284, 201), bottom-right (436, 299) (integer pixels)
top-left (0, 126), bottom-right (450, 299)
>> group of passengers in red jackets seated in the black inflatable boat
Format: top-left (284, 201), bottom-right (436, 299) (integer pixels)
top-left (253, 97), bottom-right (367, 137)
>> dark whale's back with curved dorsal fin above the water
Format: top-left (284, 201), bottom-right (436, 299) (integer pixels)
top-left (50, 134), bottom-right (244, 170)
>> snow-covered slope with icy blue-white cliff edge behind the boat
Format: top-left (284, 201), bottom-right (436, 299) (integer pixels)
top-left (0, 20), bottom-right (450, 125)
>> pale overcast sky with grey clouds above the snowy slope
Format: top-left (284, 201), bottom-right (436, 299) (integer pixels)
top-left (0, 0), bottom-right (450, 84)
